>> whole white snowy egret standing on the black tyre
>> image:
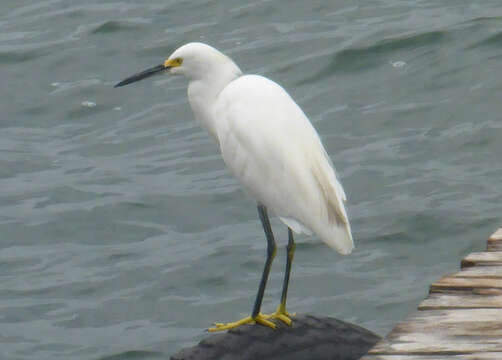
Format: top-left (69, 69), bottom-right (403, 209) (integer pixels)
top-left (115, 43), bottom-right (354, 331)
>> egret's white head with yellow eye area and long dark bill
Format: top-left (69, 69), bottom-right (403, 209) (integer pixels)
top-left (115, 43), bottom-right (241, 87)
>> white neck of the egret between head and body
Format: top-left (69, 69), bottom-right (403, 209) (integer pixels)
top-left (188, 62), bottom-right (242, 139)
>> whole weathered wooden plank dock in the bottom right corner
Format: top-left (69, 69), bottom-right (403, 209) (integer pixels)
top-left (362, 228), bottom-right (502, 360)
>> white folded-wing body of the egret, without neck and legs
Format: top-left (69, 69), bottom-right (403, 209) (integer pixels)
top-left (214, 75), bottom-right (353, 254)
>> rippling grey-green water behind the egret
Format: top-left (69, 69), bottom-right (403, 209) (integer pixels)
top-left (0, 0), bottom-right (502, 360)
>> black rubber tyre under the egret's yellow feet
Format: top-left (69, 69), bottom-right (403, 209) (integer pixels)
top-left (171, 315), bottom-right (380, 360)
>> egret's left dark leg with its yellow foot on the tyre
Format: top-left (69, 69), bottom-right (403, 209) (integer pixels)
top-left (209, 204), bottom-right (277, 331)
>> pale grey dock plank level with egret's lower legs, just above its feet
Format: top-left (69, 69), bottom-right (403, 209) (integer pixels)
top-left (418, 293), bottom-right (502, 311)
